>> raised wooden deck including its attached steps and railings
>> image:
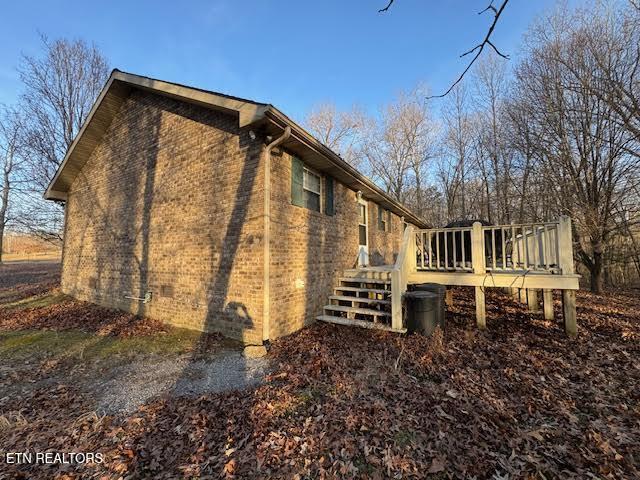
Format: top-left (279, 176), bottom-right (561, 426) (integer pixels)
top-left (317, 217), bottom-right (580, 336)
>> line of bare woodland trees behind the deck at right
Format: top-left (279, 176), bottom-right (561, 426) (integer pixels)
top-left (306, 2), bottom-right (640, 292)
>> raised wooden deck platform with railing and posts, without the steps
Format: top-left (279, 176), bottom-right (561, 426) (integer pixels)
top-left (384, 217), bottom-right (580, 336)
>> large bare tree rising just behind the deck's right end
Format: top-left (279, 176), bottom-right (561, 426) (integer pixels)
top-left (517, 3), bottom-right (639, 292)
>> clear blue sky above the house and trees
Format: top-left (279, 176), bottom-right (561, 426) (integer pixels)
top-left (0, 0), bottom-right (580, 120)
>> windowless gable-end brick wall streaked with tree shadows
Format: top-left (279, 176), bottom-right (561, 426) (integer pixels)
top-left (62, 91), bottom-right (264, 342)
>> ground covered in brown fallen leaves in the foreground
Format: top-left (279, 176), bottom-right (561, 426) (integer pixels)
top-left (0, 266), bottom-right (640, 479)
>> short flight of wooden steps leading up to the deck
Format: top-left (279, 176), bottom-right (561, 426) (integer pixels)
top-left (317, 266), bottom-right (404, 332)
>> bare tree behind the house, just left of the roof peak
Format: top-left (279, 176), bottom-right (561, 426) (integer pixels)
top-left (19, 36), bottom-right (109, 238)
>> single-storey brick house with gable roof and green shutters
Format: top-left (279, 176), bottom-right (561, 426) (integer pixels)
top-left (45, 70), bottom-right (425, 343)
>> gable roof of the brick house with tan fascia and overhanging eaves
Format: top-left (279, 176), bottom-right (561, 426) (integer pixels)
top-left (44, 70), bottom-right (427, 227)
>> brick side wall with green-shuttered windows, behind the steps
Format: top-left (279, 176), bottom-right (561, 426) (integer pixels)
top-left (270, 153), bottom-right (403, 338)
